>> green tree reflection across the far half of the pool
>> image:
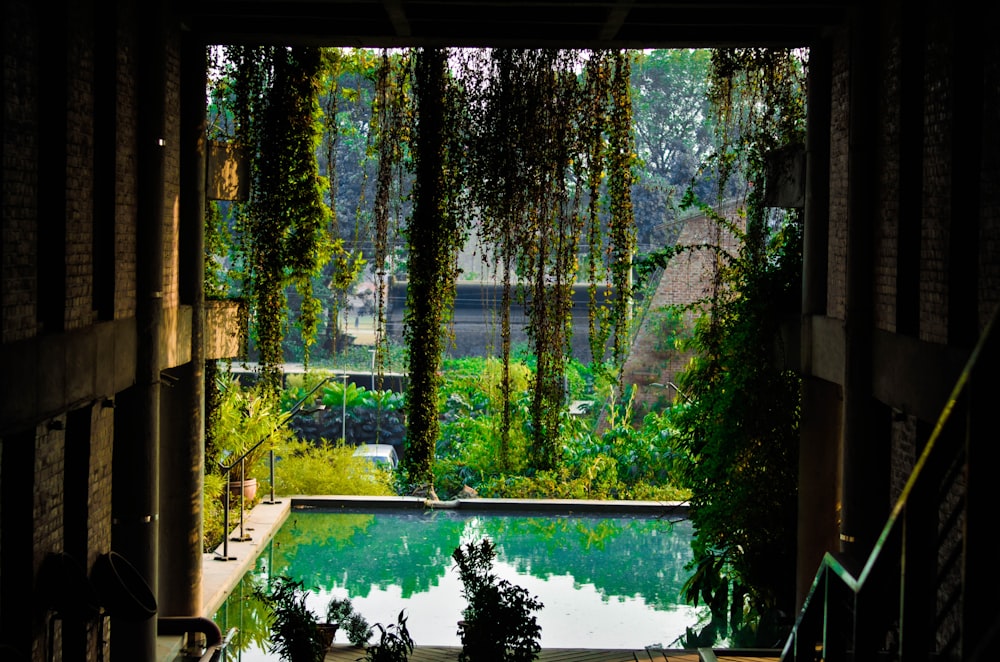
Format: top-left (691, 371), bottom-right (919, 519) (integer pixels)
top-left (258, 511), bottom-right (691, 609)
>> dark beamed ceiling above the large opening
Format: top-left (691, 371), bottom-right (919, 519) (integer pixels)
top-left (175, 0), bottom-right (857, 48)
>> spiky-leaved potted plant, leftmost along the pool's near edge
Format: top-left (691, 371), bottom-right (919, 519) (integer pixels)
top-left (254, 575), bottom-right (336, 662)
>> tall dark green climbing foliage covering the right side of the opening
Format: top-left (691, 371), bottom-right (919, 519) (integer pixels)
top-left (664, 49), bottom-right (805, 645)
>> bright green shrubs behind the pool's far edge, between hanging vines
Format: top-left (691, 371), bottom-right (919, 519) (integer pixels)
top-left (434, 357), bottom-right (689, 500)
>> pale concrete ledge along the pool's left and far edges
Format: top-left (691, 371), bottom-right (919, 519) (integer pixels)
top-left (202, 495), bottom-right (688, 618)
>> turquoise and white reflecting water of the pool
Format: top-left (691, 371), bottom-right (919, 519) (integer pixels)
top-left (215, 510), bottom-right (708, 661)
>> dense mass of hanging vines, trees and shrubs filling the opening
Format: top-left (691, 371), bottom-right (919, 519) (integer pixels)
top-left (208, 49), bottom-right (805, 645)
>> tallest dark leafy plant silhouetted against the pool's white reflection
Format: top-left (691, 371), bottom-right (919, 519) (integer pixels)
top-left (452, 538), bottom-right (543, 662)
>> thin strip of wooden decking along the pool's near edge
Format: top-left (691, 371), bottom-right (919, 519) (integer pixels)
top-left (325, 644), bottom-right (779, 662)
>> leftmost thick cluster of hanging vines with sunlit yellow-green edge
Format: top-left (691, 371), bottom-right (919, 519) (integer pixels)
top-left (217, 46), bottom-right (370, 391)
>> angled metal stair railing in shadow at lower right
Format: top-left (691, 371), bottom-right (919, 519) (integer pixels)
top-left (781, 314), bottom-right (998, 662)
